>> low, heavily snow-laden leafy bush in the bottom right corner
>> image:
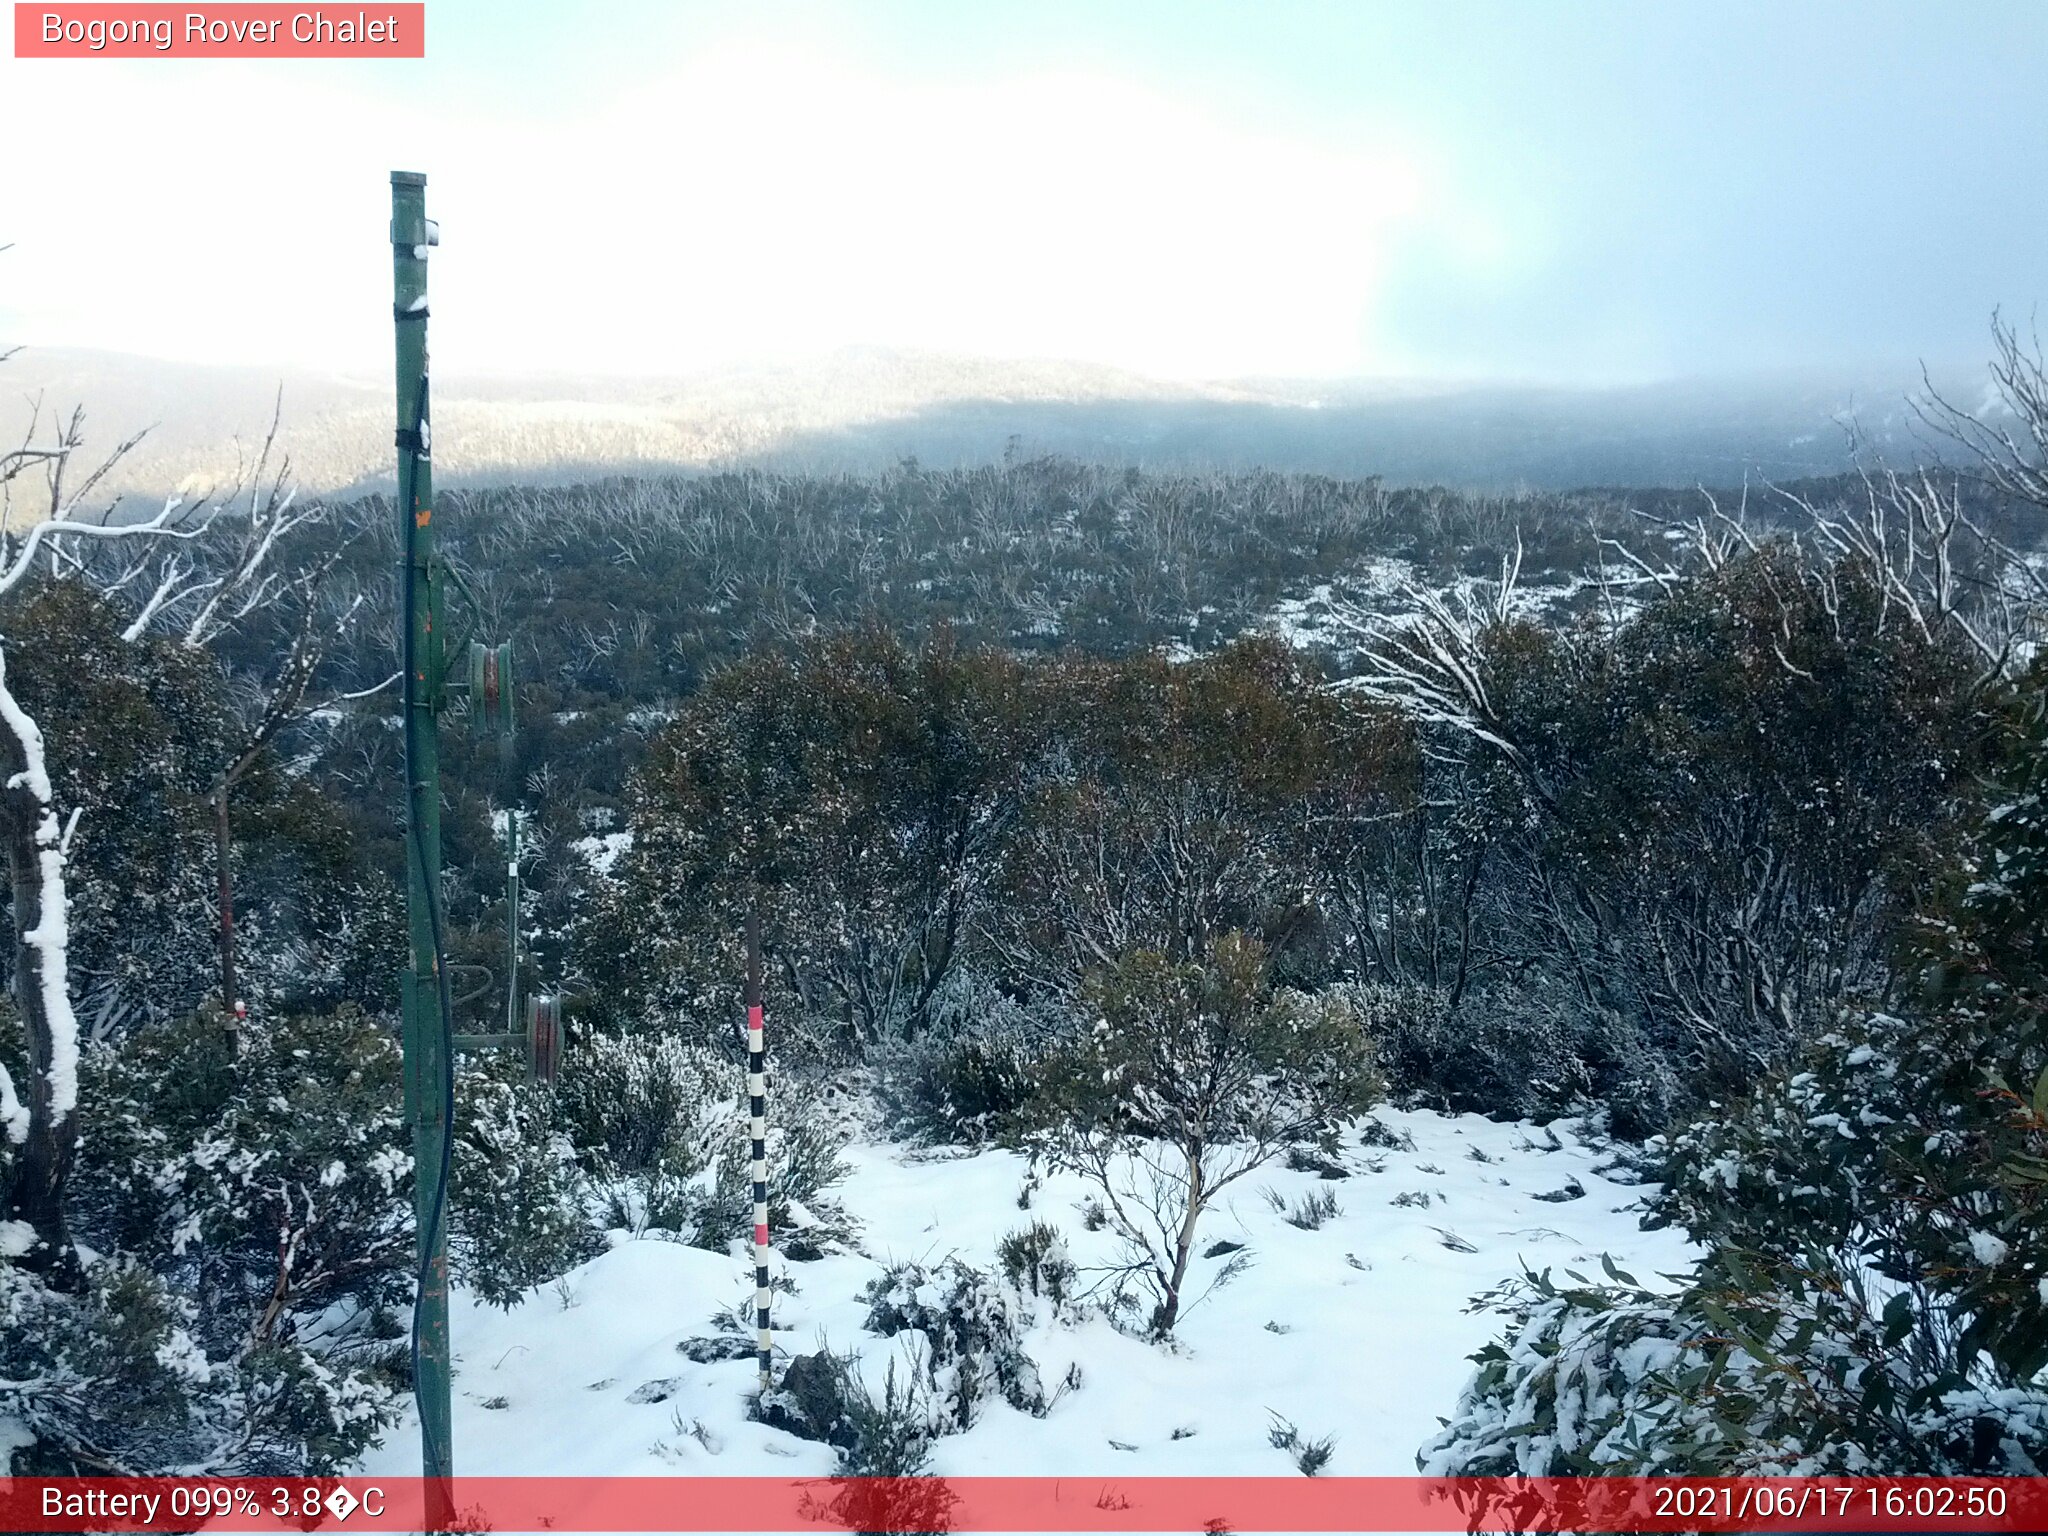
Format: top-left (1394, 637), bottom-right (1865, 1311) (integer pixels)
top-left (1417, 1249), bottom-right (2048, 1477)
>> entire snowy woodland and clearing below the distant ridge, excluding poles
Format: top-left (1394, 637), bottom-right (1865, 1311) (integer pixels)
top-left (0, 328), bottom-right (2048, 1475)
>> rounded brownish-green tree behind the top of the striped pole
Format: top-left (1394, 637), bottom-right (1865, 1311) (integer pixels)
top-left (582, 633), bottom-right (1020, 1053)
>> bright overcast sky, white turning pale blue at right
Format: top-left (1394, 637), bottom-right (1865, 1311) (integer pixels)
top-left (0, 0), bottom-right (2048, 383)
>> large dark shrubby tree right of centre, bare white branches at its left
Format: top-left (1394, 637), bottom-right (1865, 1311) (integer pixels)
top-left (1356, 539), bottom-right (1982, 1105)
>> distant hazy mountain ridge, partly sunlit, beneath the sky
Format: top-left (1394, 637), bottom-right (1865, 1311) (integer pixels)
top-left (0, 348), bottom-right (1980, 496)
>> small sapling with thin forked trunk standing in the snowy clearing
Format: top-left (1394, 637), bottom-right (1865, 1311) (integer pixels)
top-left (1032, 934), bottom-right (1380, 1335)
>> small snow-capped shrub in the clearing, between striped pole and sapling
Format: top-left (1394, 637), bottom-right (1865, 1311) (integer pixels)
top-left (862, 1257), bottom-right (1044, 1430)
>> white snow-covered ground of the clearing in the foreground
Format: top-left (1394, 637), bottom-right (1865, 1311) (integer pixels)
top-left (362, 1110), bottom-right (1692, 1477)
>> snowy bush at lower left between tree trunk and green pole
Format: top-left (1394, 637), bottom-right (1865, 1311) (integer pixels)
top-left (19, 1010), bottom-right (412, 1475)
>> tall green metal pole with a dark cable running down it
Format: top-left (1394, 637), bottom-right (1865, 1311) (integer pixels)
top-left (391, 170), bottom-right (455, 1507)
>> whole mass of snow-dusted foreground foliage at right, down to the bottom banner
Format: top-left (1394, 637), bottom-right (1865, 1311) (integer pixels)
top-left (1421, 674), bottom-right (2048, 1477)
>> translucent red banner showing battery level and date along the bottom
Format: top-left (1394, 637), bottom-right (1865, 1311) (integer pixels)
top-left (0, 1477), bottom-right (2048, 1532)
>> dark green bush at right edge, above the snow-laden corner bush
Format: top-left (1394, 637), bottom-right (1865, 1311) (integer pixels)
top-left (1663, 671), bottom-right (2048, 1391)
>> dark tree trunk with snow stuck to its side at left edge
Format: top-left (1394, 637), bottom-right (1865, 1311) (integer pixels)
top-left (0, 774), bottom-right (80, 1290)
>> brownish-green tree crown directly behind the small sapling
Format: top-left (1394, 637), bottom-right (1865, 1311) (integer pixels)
top-left (979, 639), bottom-right (1403, 997)
